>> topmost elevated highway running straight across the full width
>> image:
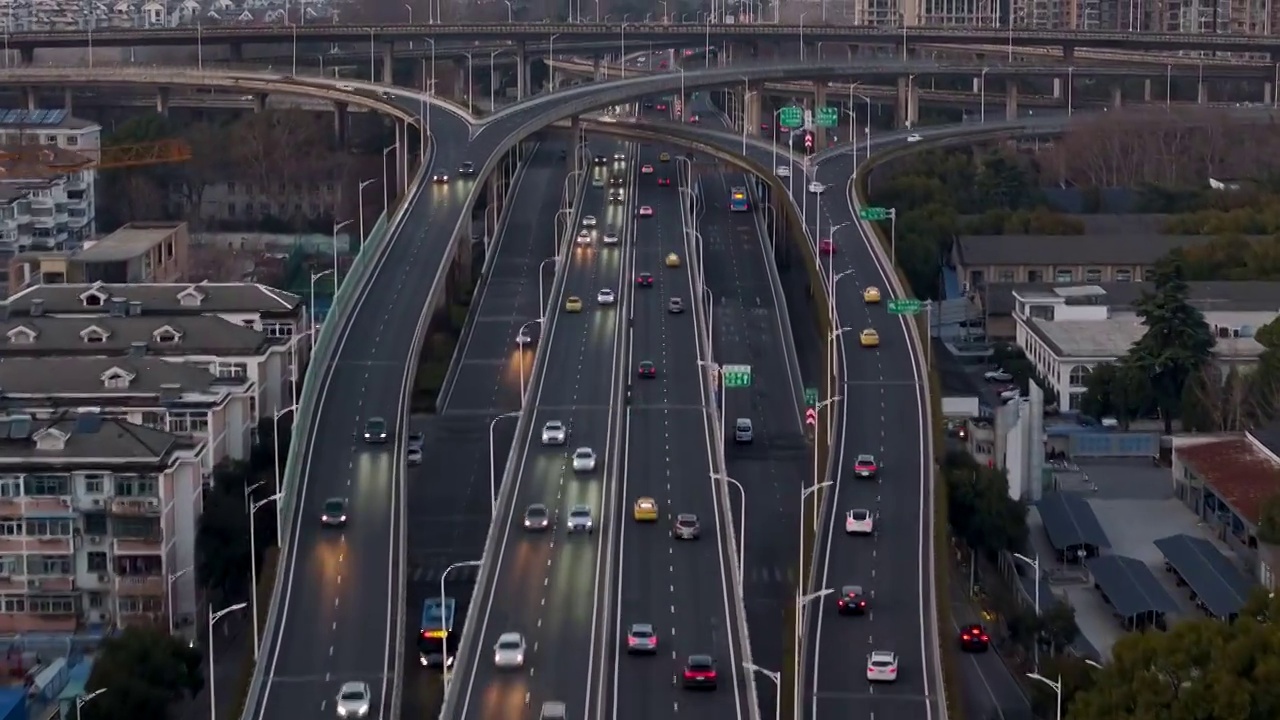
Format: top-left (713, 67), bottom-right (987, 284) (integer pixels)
top-left (9, 22), bottom-right (1280, 59)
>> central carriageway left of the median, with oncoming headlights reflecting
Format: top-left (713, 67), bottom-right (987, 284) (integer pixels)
top-left (453, 141), bottom-right (630, 720)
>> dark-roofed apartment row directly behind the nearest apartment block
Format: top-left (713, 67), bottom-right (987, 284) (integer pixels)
top-left (0, 356), bottom-right (257, 478)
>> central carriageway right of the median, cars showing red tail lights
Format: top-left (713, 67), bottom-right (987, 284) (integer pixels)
top-left (608, 145), bottom-right (750, 720)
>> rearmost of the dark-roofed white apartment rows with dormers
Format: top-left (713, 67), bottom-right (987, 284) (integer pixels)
top-left (0, 283), bottom-right (312, 418)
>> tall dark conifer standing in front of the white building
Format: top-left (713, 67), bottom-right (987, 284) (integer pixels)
top-left (1125, 263), bottom-right (1215, 434)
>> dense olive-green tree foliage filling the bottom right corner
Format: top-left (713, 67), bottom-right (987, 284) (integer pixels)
top-left (1066, 592), bottom-right (1280, 720)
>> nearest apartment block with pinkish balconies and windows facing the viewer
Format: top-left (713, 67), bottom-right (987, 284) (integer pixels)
top-left (0, 411), bottom-right (201, 634)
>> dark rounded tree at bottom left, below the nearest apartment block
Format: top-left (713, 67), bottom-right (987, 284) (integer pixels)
top-left (77, 625), bottom-right (204, 720)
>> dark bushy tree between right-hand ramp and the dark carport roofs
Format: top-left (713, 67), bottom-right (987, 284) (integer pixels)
top-left (943, 452), bottom-right (1027, 557)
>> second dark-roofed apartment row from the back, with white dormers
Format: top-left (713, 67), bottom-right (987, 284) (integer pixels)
top-left (0, 300), bottom-right (296, 418)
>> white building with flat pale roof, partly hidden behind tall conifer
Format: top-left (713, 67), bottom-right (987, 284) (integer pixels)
top-left (1014, 283), bottom-right (1280, 411)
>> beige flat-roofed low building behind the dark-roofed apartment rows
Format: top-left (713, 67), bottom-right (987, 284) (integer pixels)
top-left (6, 222), bottom-right (191, 295)
